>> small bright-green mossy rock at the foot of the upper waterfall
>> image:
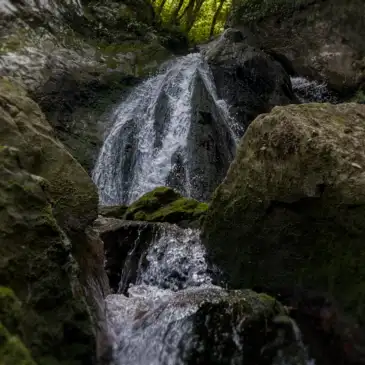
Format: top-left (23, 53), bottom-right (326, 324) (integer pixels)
top-left (124, 186), bottom-right (208, 226)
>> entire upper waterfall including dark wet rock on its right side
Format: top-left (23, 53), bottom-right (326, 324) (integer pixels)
top-left (93, 54), bottom-right (236, 205)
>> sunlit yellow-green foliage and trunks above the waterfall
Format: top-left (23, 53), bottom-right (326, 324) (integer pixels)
top-left (152, 0), bottom-right (232, 43)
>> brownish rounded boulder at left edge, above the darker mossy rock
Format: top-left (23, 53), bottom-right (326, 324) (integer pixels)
top-left (0, 77), bottom-right (98, 232)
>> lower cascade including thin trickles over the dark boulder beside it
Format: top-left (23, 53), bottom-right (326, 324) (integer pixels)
top-left (106, 224), bottom-right (314, 365)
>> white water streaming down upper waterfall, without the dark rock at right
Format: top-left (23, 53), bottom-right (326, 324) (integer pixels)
top-left (93, 54), bottom-right (234, 205)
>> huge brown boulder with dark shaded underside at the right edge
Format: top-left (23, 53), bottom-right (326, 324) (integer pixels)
top-left (203, 103), bottom-right (365, 364)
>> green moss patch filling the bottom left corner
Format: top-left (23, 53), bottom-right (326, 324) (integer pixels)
top-left (0, 322), bottom-right (36, 365)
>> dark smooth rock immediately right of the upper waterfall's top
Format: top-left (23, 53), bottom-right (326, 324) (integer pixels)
top-left (203, 29), bottom-right (297, 135)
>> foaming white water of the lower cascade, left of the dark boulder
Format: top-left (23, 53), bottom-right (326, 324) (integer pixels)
top-left (106, 225), bottom-right (219, 365)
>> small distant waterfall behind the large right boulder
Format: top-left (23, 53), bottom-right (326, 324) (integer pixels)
top-left (291, 76), bottom-right (337, 103)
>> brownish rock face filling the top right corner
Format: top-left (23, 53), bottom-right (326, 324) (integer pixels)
top-left (228, 0), bottom-right (365, 94)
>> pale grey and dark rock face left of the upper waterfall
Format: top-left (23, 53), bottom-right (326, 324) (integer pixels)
top-left (0, 0), bottom-right (179, 171)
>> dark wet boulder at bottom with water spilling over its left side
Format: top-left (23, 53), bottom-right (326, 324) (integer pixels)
top-left (107, 286), bottom-right (307, 365)
